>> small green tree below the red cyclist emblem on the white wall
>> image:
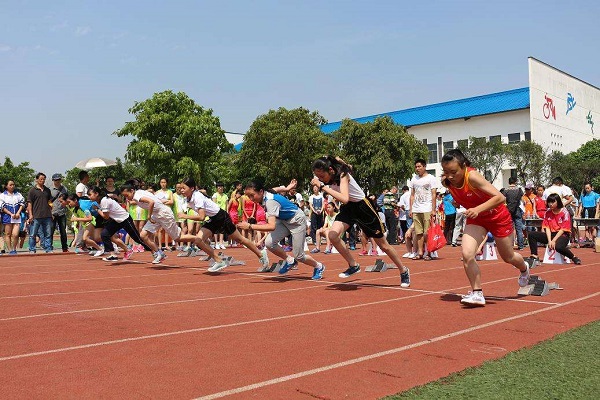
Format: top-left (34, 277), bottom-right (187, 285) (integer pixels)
top-left (505, 140), bottom-right (548, 185)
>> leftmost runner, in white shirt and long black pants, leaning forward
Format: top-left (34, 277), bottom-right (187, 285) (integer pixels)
top-left (90, 191), bottom-right (151, 261)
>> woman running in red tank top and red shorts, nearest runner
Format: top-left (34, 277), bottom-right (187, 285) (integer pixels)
top-left (442, 149), bottom-right (529, 306)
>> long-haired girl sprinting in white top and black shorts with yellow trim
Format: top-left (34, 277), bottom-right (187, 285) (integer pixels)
top-left (310, 156), bottom-right (410, 288)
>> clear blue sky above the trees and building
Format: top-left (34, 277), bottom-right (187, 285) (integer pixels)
top-left (0, 0), bottom-right (600, 174)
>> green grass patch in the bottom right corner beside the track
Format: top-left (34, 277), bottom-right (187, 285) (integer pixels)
top-left (386, 321), bottom-right (600, 400)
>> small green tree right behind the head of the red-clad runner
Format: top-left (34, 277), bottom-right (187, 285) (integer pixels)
top-left (459, 136), bottom-right (506, 182)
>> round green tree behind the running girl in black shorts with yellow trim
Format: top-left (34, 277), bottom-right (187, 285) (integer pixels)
top-left (333, 117), bottom-right (428, 193)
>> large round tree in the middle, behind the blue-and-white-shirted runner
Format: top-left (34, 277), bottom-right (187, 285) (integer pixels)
top-left (234, 107), bottom-right (333, 187)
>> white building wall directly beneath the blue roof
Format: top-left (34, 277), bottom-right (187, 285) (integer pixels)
top-left (408, 109), bottom-right (531, 188)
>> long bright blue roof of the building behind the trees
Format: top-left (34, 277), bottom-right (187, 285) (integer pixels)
top-left (321, 87), bottom-right (529, 133)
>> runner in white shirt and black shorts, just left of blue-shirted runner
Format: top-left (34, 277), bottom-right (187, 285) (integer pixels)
top-left (178, 178), bottom-right (269, 272)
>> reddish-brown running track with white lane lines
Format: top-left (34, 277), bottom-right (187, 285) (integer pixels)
top-left (0, 247), bottom-right (600, 399)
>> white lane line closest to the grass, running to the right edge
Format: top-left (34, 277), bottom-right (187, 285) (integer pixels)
top-left (195, 292), bottom-right (600, 400)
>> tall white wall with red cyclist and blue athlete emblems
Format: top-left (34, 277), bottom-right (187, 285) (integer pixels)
top-left (529, 57), bottom-right (600, 154)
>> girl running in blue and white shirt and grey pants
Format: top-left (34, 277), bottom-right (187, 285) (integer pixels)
top-left (238, 181), bottom-right (325, 280)
